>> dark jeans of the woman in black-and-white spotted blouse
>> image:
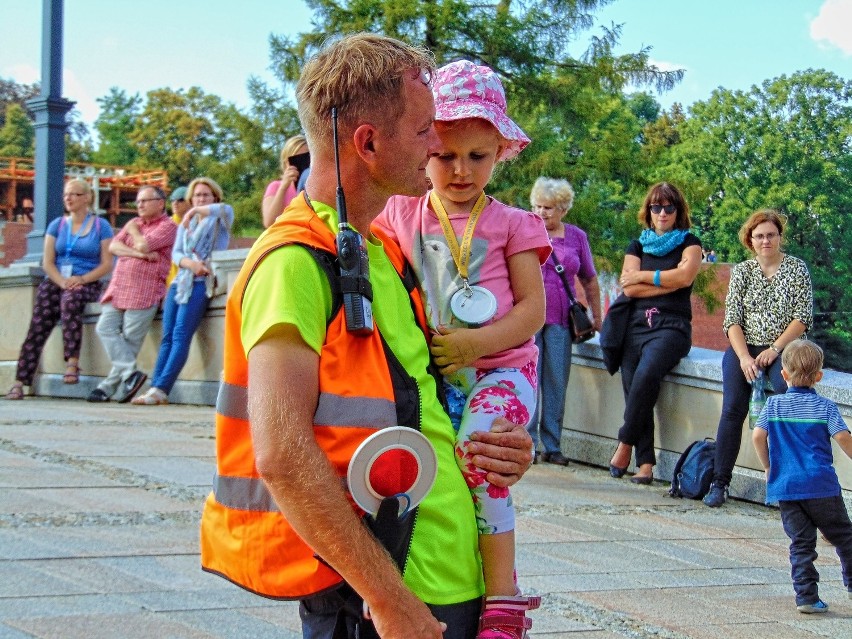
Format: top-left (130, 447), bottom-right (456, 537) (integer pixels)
top-left (713, 345), bottom-right (787, 486)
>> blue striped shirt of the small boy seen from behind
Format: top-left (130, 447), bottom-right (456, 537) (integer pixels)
top-left (755, 387), bottom-right (849, 504)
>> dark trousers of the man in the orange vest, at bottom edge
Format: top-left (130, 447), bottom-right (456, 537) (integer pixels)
top-left (299, 584), bottom-right (482, 639)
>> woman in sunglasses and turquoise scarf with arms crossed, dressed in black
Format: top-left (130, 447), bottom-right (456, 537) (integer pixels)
top-left (601, 182), bottom-right (701, 484)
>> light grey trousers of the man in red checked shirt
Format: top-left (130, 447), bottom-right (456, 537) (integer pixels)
top-left (95, 302), bottom-right (159, 397)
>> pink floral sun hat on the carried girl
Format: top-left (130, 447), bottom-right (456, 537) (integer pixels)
top-left (432, 60), bottom-right (530, 160)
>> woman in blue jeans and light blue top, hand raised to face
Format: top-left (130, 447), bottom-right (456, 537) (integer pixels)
top-left (133, 177), bottom-right (234, 405)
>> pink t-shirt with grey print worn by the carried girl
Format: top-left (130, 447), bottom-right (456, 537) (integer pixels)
top-left (374, 194), bottom-right (550, 369)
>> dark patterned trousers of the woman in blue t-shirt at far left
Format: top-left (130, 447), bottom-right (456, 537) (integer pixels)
top-left (15, 278), bottom-right (101, 386)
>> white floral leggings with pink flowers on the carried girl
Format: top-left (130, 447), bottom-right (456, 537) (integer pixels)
top-left (444, 362), bottom-right (537, 535)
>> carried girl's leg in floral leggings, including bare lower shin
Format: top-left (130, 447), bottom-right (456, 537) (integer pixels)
top-left (445, 368), bottom-right (535, 596)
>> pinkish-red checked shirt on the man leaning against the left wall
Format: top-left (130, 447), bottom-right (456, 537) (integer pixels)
top-left (101, 213), bottom-right (177, 311)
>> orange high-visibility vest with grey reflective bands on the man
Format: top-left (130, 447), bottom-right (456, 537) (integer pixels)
top-left (201, 194), bottom-right (428, 599)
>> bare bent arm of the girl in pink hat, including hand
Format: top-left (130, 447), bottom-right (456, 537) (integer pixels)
top-left (432, 251), bottom-right (544, 375)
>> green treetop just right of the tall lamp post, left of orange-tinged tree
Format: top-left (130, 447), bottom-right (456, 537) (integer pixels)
top-left (92, 87), bottom-right (142, 166)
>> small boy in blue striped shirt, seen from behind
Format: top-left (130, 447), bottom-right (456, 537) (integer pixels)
top-left (752, 340), bottom-right (852, 614)
